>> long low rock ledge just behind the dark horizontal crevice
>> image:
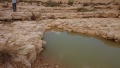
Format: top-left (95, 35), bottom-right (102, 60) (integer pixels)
top-left (0, 11), bottom-right (119, 21)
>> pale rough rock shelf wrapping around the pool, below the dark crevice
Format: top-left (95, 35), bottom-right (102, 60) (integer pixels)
top-left (0, 18), bottom-right (120, 67)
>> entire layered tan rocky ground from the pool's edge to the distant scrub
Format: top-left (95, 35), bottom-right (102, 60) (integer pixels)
top-left (0, 2), bottom-right (120, 68)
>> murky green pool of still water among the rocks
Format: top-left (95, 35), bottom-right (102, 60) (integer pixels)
top-left (43, 31), bottom-right (120, 68)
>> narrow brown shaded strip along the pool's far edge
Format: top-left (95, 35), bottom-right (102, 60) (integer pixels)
top-left (46, 29), bottom-right (120, 48)
